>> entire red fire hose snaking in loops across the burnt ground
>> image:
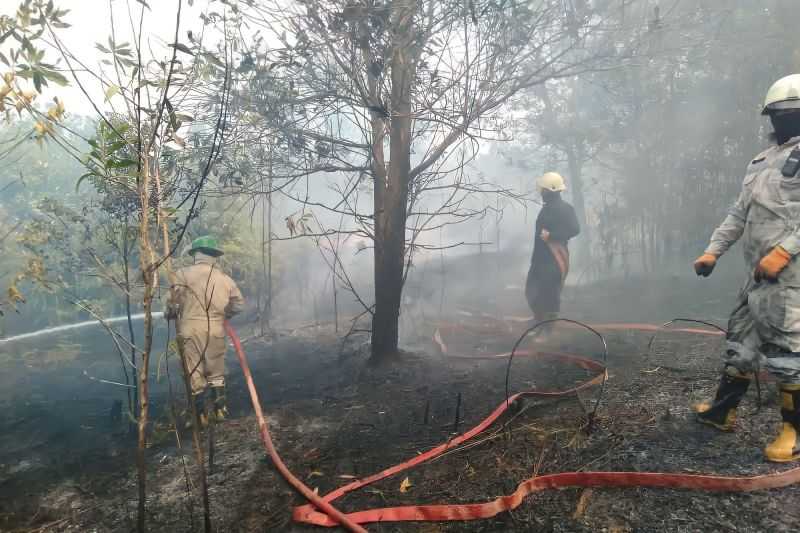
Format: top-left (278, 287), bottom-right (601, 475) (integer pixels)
top-left (225, 323), bottom-right (800, 531)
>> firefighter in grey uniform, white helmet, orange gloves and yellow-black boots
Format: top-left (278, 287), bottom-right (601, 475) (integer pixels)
top-left (694, 74), bottom-right (800, 462)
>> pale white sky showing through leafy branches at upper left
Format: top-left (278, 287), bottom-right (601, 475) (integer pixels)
top-left (0, 0), bottom-right (217, 116)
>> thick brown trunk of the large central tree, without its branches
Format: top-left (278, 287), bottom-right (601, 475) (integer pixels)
top-left (372, 1), bottom-right (416, 359)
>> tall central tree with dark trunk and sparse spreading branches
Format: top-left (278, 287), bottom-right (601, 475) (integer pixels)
top-left (245, 0), bottom-right (617, 359)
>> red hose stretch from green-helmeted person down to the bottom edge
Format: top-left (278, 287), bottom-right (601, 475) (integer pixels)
top-left (225, 320), bottom-right (367, 533)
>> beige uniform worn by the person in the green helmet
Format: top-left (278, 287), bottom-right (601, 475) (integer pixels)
top-left (167, 253), bottom-right (244, 394)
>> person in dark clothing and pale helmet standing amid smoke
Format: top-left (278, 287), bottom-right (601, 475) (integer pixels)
top-left (525, 172), bottom-right (580, 329)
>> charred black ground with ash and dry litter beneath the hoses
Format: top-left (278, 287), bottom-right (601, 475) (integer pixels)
top-left (0, 272), bottom-right (800, 532)
